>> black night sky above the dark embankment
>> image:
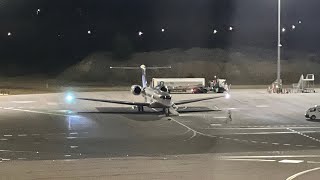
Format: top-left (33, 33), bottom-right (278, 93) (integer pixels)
top-left (0, 0), bottom-right (320, 72)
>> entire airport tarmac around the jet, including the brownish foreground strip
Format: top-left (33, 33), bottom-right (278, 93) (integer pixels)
top-left (0, 89), bottom-right (320, 179)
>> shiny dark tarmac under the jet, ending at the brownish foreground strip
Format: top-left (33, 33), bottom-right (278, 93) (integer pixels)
top-left (0, 90), bottom-right (320, 161)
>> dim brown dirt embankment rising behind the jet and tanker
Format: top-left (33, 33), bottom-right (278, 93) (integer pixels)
top-left (58, 48), bottom-right (320, 85)
